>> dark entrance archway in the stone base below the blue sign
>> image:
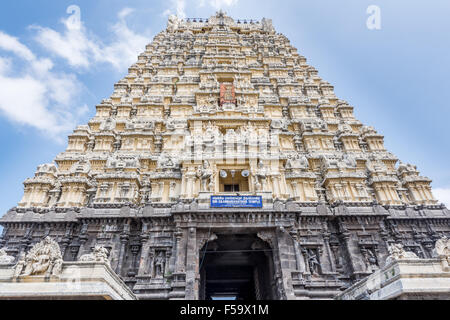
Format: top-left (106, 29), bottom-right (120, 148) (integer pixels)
top-left (200, 234), bottom-right (275, 301)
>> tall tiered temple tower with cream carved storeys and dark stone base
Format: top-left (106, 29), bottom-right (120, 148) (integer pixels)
top-left (0, 12), bottom-right (450, 299)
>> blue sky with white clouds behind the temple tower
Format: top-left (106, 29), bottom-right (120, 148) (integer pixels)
top-left (0, 0), bottom-right (450, 222)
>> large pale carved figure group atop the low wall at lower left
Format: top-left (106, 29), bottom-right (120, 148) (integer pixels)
top-left (15, 237), bottom-right (63, 276)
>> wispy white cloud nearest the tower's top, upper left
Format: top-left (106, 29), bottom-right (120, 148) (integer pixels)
top-left (33, 8), bottom-right (150, 71)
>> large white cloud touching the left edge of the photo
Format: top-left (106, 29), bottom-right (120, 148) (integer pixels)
top-left (0, 31), bottom-right (86, 142)
